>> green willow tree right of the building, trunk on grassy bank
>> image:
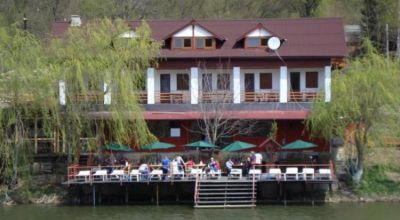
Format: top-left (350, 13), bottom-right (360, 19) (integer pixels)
top-left (306, 41), bottom-right (400, 182)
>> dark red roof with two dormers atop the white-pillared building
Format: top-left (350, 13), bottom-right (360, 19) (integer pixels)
top-left (52, 18), bottom-right (346, 58)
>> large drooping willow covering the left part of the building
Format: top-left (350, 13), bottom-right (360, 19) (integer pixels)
top-left (48, 19), bottom-right (161, 163)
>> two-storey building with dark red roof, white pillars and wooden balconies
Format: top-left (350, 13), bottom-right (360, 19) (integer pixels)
top-left (52, 17), bottom-right (346, 154)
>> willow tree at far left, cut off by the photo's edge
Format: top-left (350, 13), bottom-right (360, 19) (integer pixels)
top-left (0, 25), bottom-right (55, 189)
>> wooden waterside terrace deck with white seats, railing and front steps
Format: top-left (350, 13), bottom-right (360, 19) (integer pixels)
top-left (64, 162), bottom-right (336, 208)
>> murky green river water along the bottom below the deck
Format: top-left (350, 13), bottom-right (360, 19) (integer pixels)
top-left (0, 203), bottom-right (400, 220)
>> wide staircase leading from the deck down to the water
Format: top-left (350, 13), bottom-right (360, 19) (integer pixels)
top-left (194, 179), bottom-right (257, 208)
